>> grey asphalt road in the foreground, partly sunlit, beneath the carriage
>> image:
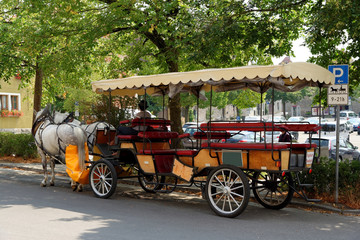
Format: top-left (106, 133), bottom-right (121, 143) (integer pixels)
top-left (0, 168), bottom-right (360, 240)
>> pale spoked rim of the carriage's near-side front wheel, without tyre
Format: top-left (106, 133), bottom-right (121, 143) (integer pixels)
top-left (91, 163), bottom-right (114, 196)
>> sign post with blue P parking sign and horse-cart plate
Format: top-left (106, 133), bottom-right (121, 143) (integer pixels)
top-left (328, 65), bottom-right (349, 203)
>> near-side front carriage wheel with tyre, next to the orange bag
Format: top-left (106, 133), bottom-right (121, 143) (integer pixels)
top-left (89, 159), bottom-right (117, 198)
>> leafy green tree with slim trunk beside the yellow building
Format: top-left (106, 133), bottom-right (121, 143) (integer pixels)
top-left (0, 0), bottom-right (97, 119)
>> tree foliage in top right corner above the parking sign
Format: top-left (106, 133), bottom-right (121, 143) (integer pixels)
top-left (306, 0), bottom-right (360, 96)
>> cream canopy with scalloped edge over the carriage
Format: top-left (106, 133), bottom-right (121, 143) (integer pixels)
top-left (92, 62), bottom-right (335, 97)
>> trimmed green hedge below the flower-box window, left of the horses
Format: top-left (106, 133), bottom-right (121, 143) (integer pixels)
top-left (0, 132), bottom-right (38, 159)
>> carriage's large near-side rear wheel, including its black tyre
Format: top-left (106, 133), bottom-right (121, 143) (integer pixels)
top-left (205, 165), bottom-right (250, 217)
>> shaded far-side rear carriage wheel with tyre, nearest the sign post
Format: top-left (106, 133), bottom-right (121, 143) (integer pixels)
top-left (252, 172), bottom-right (294, 209)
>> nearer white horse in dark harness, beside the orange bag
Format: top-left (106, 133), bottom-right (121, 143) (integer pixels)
top-left (32, 106), bottom-right (87, 191)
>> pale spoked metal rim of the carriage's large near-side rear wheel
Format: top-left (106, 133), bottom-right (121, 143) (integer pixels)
top-left (207, 169), bottom-right (246, 215)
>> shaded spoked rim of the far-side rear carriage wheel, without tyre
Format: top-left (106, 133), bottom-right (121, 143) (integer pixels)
top-left (255, 173), bottom-right (290, 206)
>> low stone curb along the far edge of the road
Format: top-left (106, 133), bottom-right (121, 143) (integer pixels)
top-left (0, 162), bottom-right (360, 214)
